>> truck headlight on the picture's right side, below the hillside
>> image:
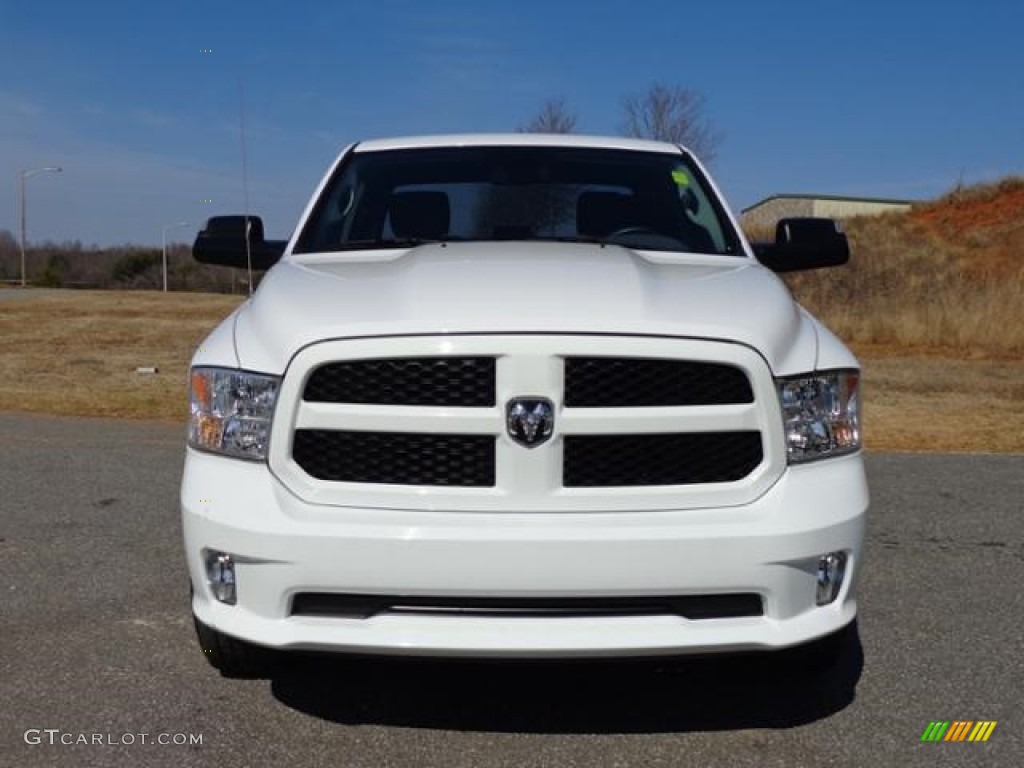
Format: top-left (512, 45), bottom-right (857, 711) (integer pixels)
top-left (776, 371), bottom-right (860, 464)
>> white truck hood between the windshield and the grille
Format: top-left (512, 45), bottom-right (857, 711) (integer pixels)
top-left (225, 243), bottom-right (817, 374)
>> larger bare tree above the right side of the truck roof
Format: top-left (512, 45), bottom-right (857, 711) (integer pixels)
top-left (623, 83), bottom-right (722, 162)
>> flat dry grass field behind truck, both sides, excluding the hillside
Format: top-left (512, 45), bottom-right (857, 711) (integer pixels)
top-left (0, 291), bottom-right (1024, 453)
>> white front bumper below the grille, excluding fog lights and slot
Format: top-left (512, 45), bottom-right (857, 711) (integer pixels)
top-left (181, 450), bottom-right (868, 657)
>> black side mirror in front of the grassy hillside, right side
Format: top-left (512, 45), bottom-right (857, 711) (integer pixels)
top-left (753, 218), bottom-right (850, 272)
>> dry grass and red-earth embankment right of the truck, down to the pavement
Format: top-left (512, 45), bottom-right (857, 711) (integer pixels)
top-left (774, 177), bottom-right (1024, 453)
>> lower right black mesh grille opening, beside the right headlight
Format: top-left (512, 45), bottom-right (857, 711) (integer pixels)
top-left (562, 432), bottom-right (763, 487)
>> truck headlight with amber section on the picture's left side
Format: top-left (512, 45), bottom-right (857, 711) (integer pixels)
top-left (188, 368), bottom-right (281, 461)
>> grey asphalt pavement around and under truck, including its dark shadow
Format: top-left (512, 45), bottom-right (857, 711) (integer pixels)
top-left (0, 414), bottom-right (1024, 768)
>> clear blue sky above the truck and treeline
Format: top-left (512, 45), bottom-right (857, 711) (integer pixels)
top-left (0, 0), bottom-right (1024, 245)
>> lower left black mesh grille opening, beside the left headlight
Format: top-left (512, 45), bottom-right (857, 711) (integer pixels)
top-left (292, 429), bottom-right (495, 487)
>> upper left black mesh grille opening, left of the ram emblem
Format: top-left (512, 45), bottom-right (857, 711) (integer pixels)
top-left (302, 357), bottom-right (495, 408)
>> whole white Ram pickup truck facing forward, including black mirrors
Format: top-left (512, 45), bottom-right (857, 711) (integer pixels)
top-left (180, 134), bottom-right (868, 676)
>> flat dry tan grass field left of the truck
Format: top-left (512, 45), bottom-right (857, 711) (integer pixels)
top-left (0, 291), bottom-right (241, 422)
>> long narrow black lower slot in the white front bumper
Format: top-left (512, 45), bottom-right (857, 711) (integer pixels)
top-left (292, 592), bottom-right (764, 620)
